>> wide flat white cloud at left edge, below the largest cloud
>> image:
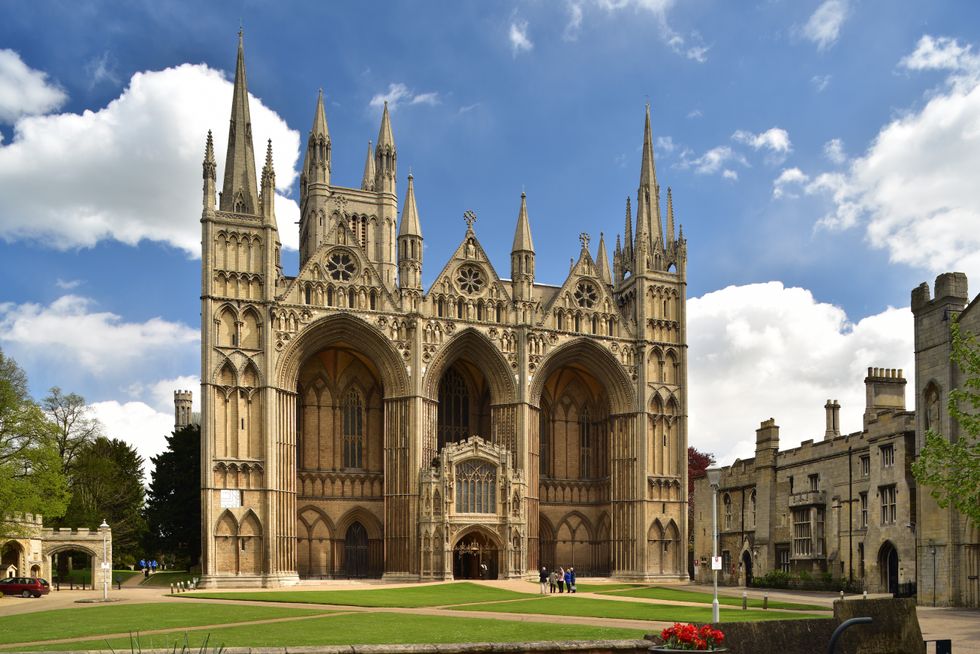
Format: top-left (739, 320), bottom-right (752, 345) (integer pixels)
top-left (0, 295), bottom-right (200, 376)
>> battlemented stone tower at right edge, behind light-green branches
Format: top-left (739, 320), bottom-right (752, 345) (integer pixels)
top-left (912, 273), bottom-right (980, 607)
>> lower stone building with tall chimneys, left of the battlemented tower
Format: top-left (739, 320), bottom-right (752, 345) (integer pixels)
top-left (694, 368), bottom-right (916, 592)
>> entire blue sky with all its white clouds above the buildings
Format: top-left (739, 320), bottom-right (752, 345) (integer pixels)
top-left (0, 0), bottom-right (980, 472)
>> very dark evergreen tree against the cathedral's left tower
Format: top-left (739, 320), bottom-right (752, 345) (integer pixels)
top-left (146, 425), bottom-right (201, 567)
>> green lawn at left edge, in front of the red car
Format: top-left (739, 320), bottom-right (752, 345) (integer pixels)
top-left (0, 599), bottom-right (323, 646)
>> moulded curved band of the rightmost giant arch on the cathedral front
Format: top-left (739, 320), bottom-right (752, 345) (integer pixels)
top-left (528, 338), bottom-right (636, 415)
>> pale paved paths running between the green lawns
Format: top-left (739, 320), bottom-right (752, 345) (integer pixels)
top-left (0, 579), bottom-right (980, 654)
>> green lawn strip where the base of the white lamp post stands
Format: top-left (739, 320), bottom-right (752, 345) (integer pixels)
top-left (454, 595), bottom-right (820, 622)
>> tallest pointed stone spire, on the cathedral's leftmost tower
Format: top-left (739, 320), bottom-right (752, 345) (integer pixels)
top-left (220, 30), bottom-right (258, 214)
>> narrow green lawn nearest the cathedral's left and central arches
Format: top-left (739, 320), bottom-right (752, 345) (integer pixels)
top-left (187, 582), bottom-right (529, 608)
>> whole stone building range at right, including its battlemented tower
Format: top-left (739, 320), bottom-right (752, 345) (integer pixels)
top-left (693, 273), bottom-right (980, 607)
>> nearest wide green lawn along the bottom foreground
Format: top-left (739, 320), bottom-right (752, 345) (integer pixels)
top-left (17, 607), bottom-right (646, 652)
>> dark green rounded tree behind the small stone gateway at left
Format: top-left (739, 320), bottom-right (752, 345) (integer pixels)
top-left (65, 436), bottom-right (146, 564)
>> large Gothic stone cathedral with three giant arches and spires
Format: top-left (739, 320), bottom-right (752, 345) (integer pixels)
top-left (201, 35), bottom-right (688, 587)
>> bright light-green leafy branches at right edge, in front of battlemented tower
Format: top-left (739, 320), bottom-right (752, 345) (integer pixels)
top-left (912, 320), bottom-right (980, 524)
